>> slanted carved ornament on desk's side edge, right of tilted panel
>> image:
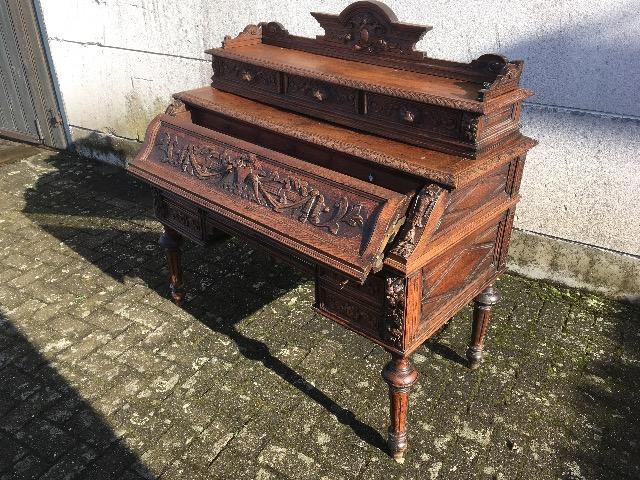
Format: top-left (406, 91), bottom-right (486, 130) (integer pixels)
top-left (391, 184), bottom-right (444, 258)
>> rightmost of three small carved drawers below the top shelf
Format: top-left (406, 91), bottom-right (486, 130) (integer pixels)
top-left (366, 92), bottom-right (462, 138)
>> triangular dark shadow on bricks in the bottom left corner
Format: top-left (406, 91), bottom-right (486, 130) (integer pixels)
top-left (0, 314), bottom-right (154, 480)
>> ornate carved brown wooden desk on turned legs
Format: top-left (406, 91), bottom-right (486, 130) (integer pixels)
top-left (129, 2), bottom-right (535, 459)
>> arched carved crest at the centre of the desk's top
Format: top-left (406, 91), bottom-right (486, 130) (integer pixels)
top-left (311, 1), bottom-right (431, 58)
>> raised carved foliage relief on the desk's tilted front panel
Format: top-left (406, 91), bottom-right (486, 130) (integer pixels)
top-left (156, 131), bottom-right (368, 236)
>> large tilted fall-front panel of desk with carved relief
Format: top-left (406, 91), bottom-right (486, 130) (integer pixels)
top-left (129, 115), bottom-right (408, 282)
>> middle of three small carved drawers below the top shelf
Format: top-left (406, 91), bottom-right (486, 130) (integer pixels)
top-left (286, 75), bottom-right (358, 115)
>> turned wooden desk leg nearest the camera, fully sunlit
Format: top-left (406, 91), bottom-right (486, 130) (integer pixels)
top-left (382, 353), bottom-right (418, 463)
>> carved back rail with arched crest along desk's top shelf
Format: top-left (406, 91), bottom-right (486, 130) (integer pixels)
top-left (229, 1), bottom-right (523, 104)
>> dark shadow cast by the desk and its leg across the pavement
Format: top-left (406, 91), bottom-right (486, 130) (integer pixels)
top-left (13, 154), bottom-right (386, 478)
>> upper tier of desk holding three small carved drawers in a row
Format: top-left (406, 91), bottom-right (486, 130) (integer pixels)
top-left (211, 52), bottom-right (522, 158)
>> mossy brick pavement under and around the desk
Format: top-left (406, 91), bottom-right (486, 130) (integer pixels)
top-left (0, 144), bottom-right (640, 480)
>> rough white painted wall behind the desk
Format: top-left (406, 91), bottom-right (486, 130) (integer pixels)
top-left (41, 0), bottom-right (640, 256)
